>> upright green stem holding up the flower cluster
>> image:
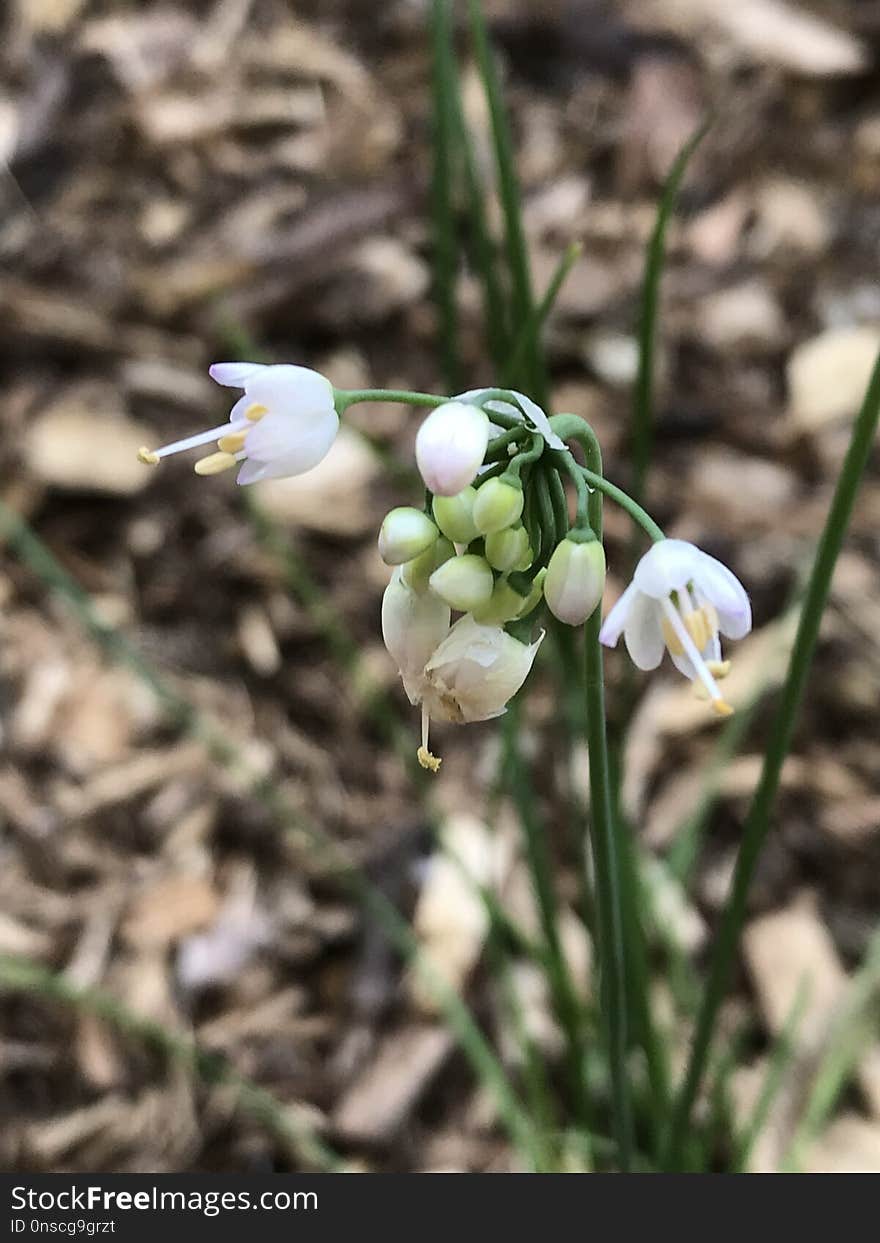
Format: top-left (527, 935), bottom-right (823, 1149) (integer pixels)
top-left (583, 424), bottom-right (633, 1172)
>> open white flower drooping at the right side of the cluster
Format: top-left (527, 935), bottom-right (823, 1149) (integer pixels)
top-left (599, 539), bottom-right (752, 716)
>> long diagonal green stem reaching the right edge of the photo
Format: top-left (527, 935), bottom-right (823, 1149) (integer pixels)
top-left (665, 357), bottom-right (880, 1168)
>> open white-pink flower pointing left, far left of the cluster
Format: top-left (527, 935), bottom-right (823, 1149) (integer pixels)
top-left (138, 363), bottom-right (339, 484)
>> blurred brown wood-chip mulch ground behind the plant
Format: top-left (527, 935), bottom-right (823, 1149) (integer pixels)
top-left (0, 0), bottom-right (880, 1172)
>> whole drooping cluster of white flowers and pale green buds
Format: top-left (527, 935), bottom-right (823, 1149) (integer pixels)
top-left (139, 363), bottom-right (752, 771)
